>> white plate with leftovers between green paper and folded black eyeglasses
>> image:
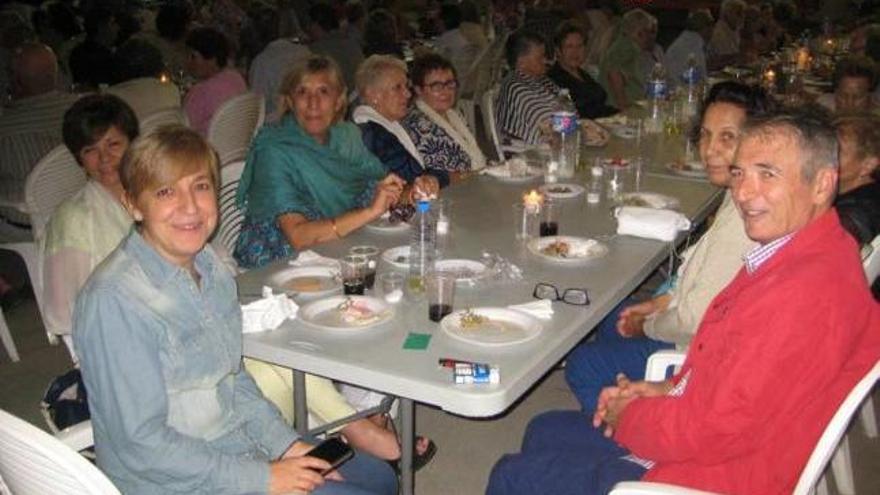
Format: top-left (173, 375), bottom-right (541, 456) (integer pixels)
top-left (440, 307), bottom-right (543, 347)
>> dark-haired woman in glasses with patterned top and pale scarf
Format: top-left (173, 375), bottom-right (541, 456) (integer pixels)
top-left (403, 53), bottom-right (486, 178)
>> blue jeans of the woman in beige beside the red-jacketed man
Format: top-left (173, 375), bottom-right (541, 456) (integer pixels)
top-left (565, 299), bottom-right (675, 413)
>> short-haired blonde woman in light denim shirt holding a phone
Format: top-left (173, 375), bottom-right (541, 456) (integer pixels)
top-left (74, 127), bottom-right (396, 495)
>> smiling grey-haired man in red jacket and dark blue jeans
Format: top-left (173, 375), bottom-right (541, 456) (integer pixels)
top-left (487, 110), bottom-right (880, 495)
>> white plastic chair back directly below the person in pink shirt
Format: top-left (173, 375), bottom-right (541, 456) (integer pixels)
top-left (208, 93), bottom-right (266, 166)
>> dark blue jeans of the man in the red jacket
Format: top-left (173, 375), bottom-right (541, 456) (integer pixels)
top-left (486, 411), bottom-right (645, 495)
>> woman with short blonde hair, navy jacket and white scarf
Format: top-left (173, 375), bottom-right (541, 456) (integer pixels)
top-left (351, 55), bottom-right (449, 201)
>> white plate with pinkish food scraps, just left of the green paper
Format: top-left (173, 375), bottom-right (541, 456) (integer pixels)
top-left (297, 296), bottom-right (394, 331)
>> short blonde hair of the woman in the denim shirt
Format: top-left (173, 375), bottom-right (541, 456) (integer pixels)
top-left (119, 124), bottom-right (220, 201)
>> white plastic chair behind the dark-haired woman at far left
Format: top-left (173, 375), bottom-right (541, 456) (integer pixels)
top-left (0, 145), bottom-right (86, 355)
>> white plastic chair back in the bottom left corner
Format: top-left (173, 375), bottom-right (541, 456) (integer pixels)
top-left (0, 410), bottom-right (119, 495)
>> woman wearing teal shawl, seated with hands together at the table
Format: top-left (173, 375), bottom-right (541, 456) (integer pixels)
top-left (234, 56), bottom-right (405, 268)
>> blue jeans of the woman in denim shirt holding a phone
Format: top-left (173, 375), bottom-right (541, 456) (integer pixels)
top-left (312, 451), bottom-right (397, 495)
